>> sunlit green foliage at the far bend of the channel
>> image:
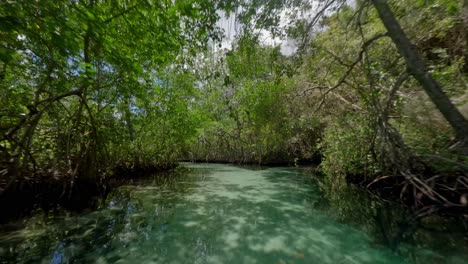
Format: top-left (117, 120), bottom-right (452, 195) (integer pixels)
top-left (187, 35), bottom-right (321, 164)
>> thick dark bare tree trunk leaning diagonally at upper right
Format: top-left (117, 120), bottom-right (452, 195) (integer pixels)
top-left (371, 0), bottom-right (468, 155)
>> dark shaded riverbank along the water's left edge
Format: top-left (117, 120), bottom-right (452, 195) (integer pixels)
top-left (0, 163), bottom-right (177, 224)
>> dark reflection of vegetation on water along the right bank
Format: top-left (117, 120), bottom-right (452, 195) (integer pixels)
top-left (319, 176), bottom-right (468, 263)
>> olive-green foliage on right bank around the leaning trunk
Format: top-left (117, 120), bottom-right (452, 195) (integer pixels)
top-left (296, 0), bottom-right (468, 186)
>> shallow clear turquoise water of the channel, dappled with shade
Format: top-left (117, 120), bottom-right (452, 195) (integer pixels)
top-left (0, 164), bottom-right (468, 264)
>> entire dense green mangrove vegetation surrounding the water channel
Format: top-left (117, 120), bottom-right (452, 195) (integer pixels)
top-left (0, 0), bottom-right (468, 219)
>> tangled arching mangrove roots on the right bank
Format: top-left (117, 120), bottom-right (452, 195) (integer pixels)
top-left (367, 119), bottom-right (468, 218)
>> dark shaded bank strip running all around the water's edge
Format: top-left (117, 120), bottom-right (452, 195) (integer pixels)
top-left (0, 157), bottom-right (468, 224)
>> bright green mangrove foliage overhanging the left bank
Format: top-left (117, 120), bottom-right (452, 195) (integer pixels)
top-left (0, 0), bottom-right (223, 178)
